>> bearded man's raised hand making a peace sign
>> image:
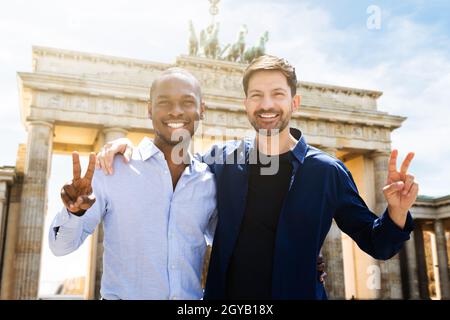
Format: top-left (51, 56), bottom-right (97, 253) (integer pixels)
top-left (383, 150), bottom-right (419, 229)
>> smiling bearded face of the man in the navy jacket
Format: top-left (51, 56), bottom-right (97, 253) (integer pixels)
top-left (244, 70), bottom-right (300, 135)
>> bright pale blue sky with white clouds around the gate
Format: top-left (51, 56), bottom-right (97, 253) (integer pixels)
top-left (0, 0), bottom-right (450, 293)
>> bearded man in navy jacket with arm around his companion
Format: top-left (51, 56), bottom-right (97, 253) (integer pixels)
top-left (98, 55), bottom-right (418, 299)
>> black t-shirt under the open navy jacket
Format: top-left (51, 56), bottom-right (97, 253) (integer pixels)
top-left (226, 151), bottom-right (292, 299)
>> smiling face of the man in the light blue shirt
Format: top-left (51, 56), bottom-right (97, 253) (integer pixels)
top-left (149, 72), bottom-right (204, 146)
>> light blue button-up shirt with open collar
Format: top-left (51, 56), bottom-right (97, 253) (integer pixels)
top-left (49, 138), bottom-right (217, 299)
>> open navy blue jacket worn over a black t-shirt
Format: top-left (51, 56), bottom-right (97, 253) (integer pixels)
top-left (203, 129), bottom-right (413, 299)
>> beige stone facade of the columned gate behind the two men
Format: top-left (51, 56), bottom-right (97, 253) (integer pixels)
top-left (0, 47), bottom-right (448, 299)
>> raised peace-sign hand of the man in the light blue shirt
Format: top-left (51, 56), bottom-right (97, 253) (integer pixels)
top-left (61, 151), bottom-right (95, 216)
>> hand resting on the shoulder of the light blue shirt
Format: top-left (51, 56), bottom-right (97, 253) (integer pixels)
top-left (95, 138), bottom-right (133, 175)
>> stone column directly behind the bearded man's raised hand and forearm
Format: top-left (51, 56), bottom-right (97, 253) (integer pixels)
top-left (372, 150), bottom-right (403, 299)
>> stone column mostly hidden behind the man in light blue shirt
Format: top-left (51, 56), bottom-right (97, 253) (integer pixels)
top-left (91, 128), bottom-right (128, 299)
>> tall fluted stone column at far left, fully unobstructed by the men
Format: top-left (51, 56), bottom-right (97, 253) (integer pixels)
top-left (14, 121), bottom-right (53, 299)
